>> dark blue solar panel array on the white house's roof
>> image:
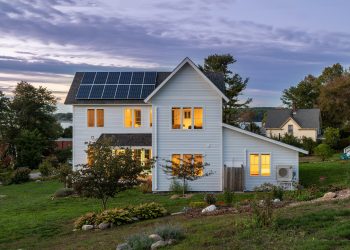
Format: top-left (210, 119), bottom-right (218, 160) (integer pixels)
top-left (76, 72), bottom-right (157, 99)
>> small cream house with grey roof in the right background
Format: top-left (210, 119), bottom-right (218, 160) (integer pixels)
top-left (265, 108), bottom-right (321, 141)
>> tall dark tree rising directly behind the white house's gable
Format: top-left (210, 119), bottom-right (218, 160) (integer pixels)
top-left (198, 54), bottom-right (251, 124)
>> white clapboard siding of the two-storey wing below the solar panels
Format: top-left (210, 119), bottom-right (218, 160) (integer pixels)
top-left (73, 105), bottom-right (152, 166)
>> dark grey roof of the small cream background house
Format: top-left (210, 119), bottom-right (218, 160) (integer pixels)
top-left (265, 109), bottom-right (321, 129)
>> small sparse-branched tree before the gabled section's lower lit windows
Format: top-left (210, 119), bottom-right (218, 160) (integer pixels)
top-left (162, 155), bottom-right (213, 196)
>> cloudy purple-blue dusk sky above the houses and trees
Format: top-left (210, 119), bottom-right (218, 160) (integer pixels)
top-left (0, 0), bottom-right (350, 112)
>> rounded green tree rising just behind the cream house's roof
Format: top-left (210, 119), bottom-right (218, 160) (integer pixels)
top-left (281, 75), bottom-right (321, 109)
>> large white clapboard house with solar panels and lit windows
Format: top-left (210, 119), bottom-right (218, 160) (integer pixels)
top-left (65, 58), bottom-right (307, 191)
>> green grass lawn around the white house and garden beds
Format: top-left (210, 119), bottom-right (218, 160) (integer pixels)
top-left (0, 156), bottom-right (350, 249)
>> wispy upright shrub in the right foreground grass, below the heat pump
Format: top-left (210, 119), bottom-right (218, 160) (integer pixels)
top-left (251, 193), bottom-right (273, 227)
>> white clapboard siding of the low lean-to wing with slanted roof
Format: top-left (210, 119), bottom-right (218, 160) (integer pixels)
top-left (223, 128), bottom-right (299, 190)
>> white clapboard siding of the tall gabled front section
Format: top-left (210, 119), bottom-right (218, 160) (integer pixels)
top-left (151, 64), bottom-right (222, 191)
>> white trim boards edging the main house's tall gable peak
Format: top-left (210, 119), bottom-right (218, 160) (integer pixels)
top-left (144, 57), bottom-right (229, 103)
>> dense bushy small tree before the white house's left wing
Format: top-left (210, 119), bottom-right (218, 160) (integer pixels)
top-left (72, 141), bottom-right (153, 209)
